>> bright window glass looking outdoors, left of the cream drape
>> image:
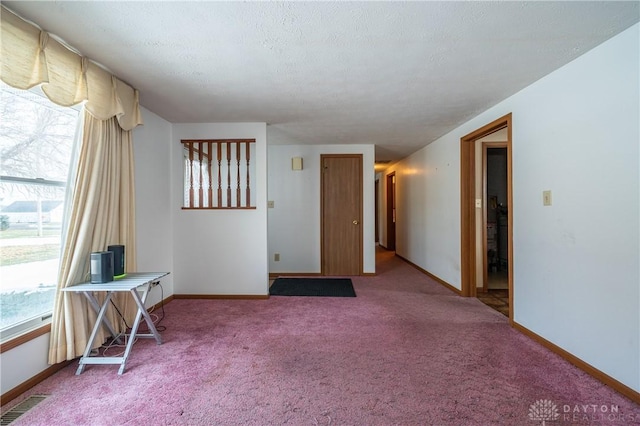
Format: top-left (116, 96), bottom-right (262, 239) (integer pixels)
top-left (0, 82), bottom-right (78, 341)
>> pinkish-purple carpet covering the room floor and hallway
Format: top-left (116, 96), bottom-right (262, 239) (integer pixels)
top-left (2, 248), bottom-right (640, 425)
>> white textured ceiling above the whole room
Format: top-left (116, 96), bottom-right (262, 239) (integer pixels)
top-left (2, 1), bottom-right (640, 160)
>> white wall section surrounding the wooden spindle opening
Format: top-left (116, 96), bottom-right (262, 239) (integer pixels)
top-left (169, 123), bottom-right (269, 295)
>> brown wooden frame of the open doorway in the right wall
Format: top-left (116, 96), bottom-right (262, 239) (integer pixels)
top-left (460, 113), bottom-right (514, 324)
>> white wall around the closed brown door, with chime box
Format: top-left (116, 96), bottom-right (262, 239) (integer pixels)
top-left (268, 145), bottom-right (375, 273)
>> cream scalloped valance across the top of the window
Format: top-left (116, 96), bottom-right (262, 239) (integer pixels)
top-left (0, 6), bottom-right (142, 130)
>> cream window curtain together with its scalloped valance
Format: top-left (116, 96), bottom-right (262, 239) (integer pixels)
top-left (0, 5), bottom-right (142, 364)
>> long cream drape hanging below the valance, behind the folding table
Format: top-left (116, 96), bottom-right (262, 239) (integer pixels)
top-left (49, 111), bottom-right (136, 364)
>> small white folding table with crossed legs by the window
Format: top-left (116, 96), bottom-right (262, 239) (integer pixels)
top-left (62, 272), bottom-right (169, 375)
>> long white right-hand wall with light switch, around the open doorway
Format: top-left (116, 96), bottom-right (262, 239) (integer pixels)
top-left (387, 25), bottom-right (640, 391)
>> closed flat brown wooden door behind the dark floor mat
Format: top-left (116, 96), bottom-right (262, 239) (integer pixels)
top-left (320, 154), bottom-right (362, 275)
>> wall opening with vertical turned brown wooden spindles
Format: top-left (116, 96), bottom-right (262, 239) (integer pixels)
top-left (181, 139), bottom-right (256, 209)
